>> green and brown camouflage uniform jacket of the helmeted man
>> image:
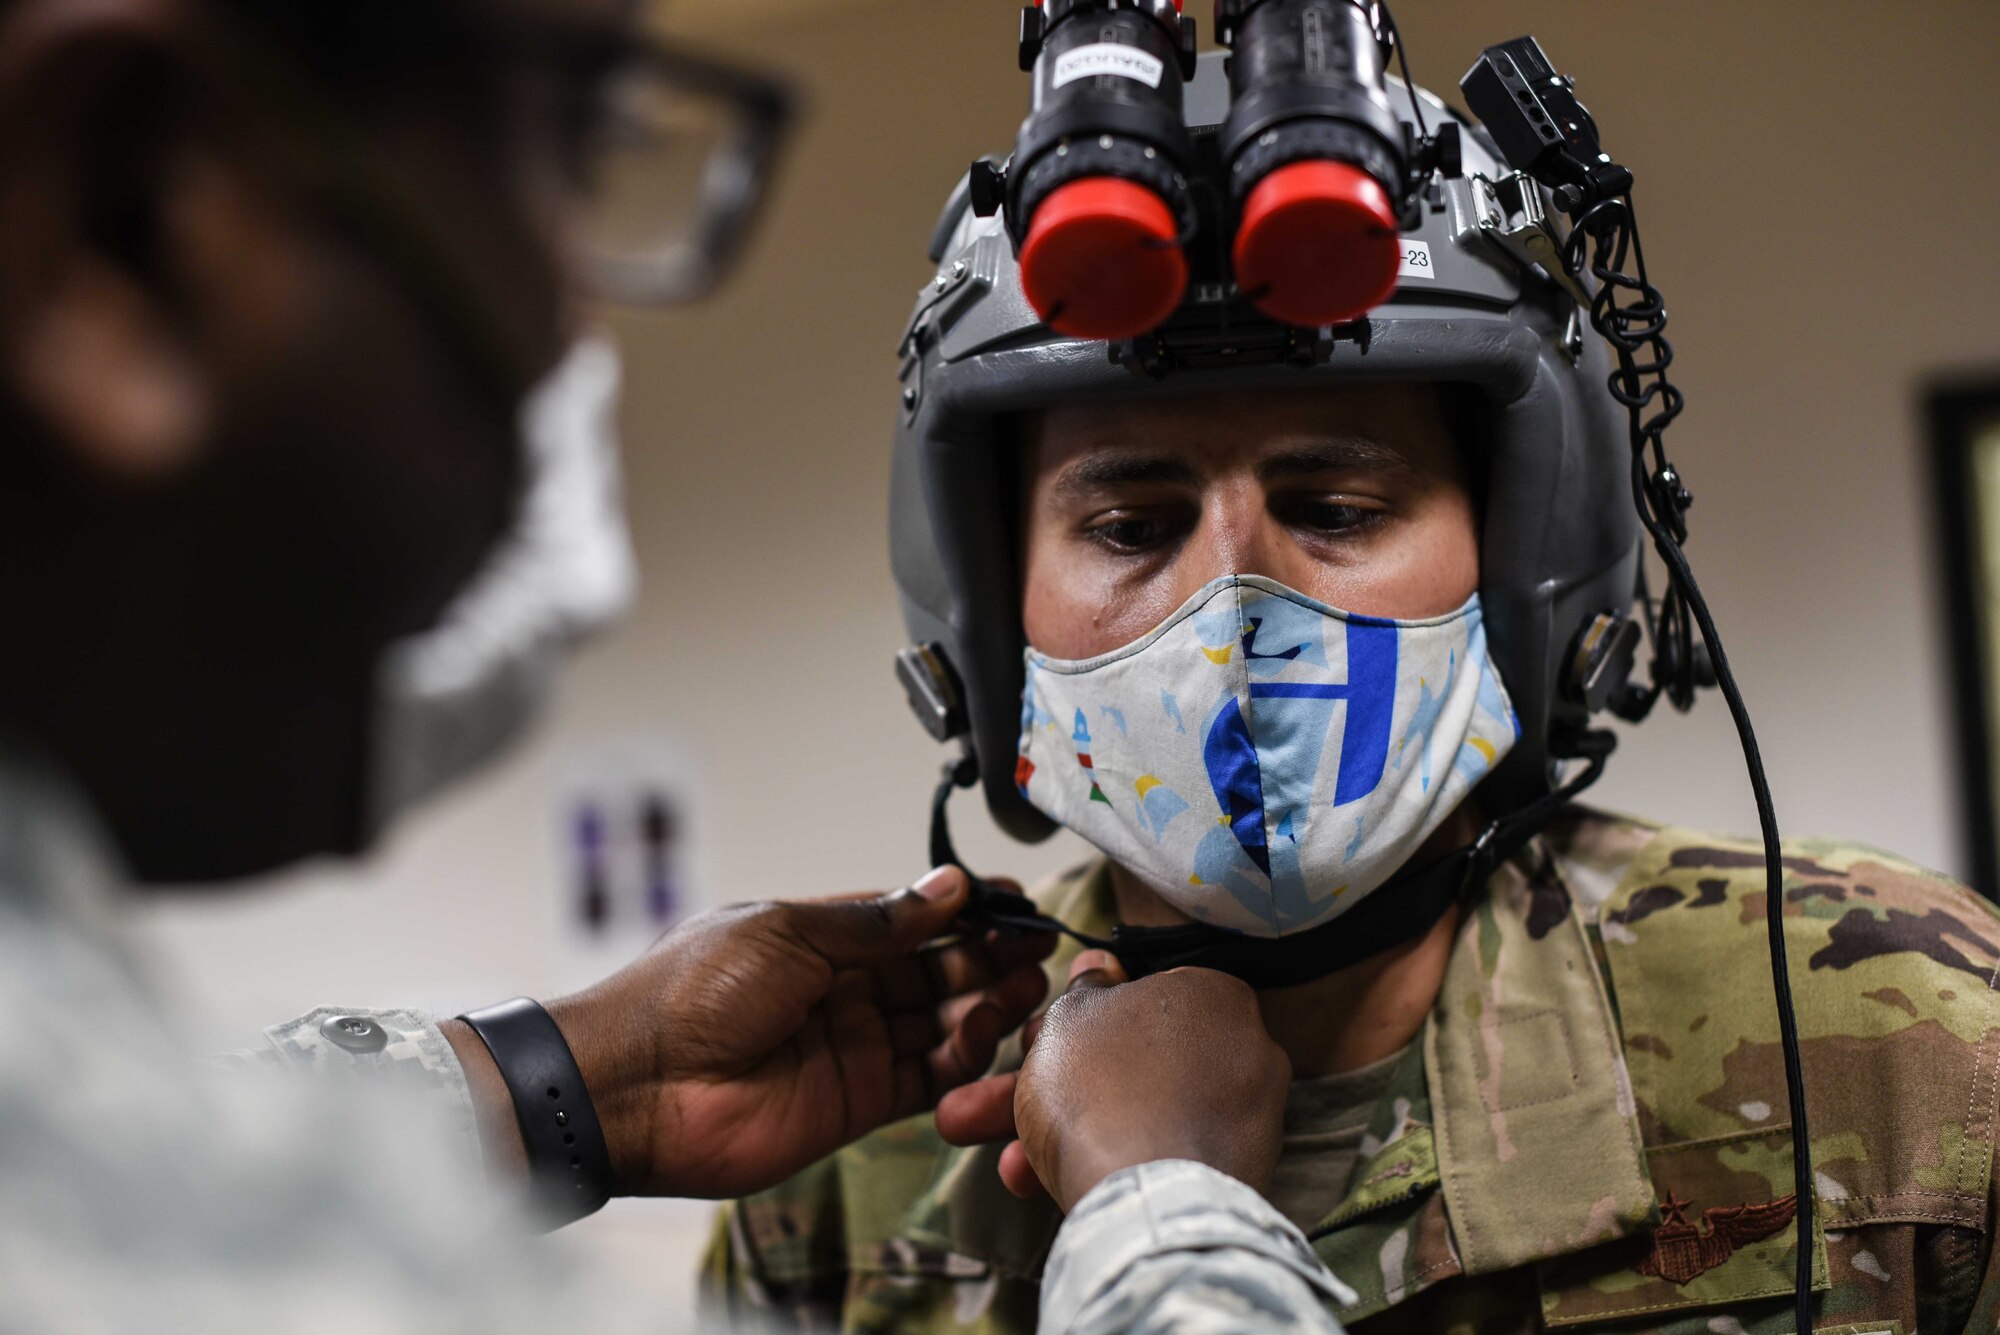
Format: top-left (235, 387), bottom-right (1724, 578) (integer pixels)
top-left (706, 809), bottom-right (2000, 1335)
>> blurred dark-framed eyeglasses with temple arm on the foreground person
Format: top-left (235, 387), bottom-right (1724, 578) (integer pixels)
top-left (189, 9), bottom-right (792, 402)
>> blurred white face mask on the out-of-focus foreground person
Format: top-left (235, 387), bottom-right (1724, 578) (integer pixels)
top-left (364, 338), bottom-right (636, 833)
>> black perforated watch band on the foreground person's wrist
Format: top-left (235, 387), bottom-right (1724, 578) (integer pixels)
top-left (460, 997), bottom-right (612, 1229)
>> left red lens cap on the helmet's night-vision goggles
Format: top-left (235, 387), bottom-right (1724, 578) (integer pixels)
top-left (1020, 176), bottom-right (1188, 340)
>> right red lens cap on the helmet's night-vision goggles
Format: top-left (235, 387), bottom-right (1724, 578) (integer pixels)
top-left (1236, 158), bottom-right (1402, 328)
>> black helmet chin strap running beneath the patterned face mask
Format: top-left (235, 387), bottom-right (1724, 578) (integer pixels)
top-left (930, 731), bottom-right (1616, 989)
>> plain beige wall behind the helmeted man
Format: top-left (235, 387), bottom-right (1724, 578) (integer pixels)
top-left (137, 0), bottom-right (2000, 1311)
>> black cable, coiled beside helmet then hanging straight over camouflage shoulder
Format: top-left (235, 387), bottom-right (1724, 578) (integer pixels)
top-left (1564, 194), bottom-right (1814, 1335)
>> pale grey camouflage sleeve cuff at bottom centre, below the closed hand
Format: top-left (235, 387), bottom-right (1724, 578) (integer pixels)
top-left (1040, 1161), bottom-right (1358, 1335)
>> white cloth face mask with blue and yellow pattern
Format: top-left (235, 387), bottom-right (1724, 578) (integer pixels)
top-left (1014, 576), bottom-right (1520, 937)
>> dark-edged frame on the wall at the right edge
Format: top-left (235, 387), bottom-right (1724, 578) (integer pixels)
top-left (1926, 379), bottom-right (2000, 903)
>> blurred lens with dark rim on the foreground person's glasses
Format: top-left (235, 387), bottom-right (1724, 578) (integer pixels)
top-left (564, 42), bottom-right (792, 306)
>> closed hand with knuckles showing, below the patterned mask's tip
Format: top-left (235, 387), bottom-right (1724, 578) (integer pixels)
top-left (938, 951), bottom-right (1292, 1213)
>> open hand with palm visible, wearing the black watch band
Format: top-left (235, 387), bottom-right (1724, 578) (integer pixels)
top-left (446, 869), bottom-right (1054, 1197)
